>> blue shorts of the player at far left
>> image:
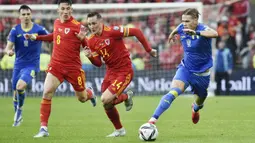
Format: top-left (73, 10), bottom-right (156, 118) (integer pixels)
top-left (12, 67), bottom-right (37, 90)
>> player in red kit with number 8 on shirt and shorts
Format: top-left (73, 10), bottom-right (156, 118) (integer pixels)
top-left (26, 0), bottom-right (96, 138)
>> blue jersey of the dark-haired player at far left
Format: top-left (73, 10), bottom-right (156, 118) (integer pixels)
top-left (8, 23), bottom-right (48, 72)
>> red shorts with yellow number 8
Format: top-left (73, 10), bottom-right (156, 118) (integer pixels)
top-left (47, 65), bottom-right (86, 92)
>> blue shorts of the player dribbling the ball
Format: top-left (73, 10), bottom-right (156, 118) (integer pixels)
top-left (174, 65), bottom-right (210, 97)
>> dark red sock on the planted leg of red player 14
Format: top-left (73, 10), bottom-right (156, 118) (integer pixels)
top-left (105, 107), bottom-right (122, 129)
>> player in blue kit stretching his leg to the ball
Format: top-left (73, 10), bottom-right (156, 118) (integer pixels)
top-left (148, 8), bottom-right (218, 124)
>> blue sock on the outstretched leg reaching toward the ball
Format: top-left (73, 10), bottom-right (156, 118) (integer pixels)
top-left (152, 88), bottom-right (182, 119)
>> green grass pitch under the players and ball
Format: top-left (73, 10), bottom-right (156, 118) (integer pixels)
top-left (0, 96), bottom-right (255, 143)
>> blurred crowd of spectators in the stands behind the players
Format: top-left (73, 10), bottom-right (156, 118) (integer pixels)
top-left (0, 0), bottom-right (255, 70)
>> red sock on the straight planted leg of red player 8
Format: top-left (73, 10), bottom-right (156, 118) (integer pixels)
top-left (40, 99), bottom-right (51, 126)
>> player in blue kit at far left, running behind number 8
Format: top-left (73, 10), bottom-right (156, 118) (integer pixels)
top-left (5, 5), bottom-right (48, 127)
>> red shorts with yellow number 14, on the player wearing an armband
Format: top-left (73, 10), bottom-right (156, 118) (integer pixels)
top-left (101, 69), bottom-right (134, 96)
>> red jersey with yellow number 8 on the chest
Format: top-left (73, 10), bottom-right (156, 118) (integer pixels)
top-left (50, 17), bottom-right (82, 69)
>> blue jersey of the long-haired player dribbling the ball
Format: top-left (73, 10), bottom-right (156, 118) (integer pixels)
top-left (177, 23), bottom-right (213, 73)
